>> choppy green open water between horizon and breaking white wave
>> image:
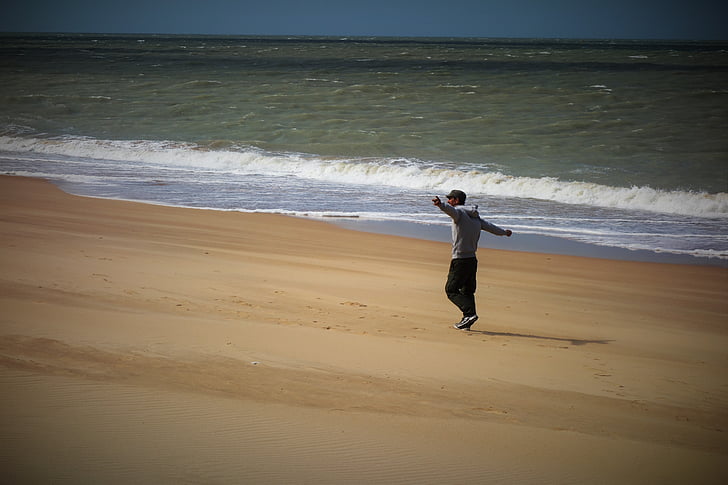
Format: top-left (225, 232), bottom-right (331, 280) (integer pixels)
top-left (0, 35), bottom-right (728, 192)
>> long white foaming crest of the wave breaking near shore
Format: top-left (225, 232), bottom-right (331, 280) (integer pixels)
top-left (0, 136), bottom-right (728, 218)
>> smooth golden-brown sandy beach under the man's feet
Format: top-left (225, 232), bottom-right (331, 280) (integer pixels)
top-left (0, 176), bottom-right (728, 484)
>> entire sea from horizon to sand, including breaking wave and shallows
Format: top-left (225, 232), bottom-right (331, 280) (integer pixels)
top-left (0, 34), bottom-right (728, 260)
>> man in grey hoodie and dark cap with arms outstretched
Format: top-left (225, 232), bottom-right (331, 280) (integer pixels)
top-left (432, 190), bottom-right (513, 330)
